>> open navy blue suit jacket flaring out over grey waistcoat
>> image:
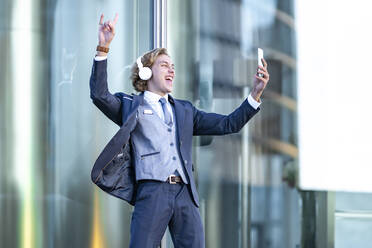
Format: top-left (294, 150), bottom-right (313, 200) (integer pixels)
top-left (90, 60), bottom-right (259, 206)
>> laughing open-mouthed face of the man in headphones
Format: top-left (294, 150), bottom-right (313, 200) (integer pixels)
top-left (147, 54), bottom-right (175, 96)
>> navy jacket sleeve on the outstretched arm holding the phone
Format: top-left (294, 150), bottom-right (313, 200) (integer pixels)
top-left (192, 99), bottom-right (260, 135)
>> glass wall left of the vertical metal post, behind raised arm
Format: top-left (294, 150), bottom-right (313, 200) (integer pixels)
top-left (0, 0), bottom-right (152, 247)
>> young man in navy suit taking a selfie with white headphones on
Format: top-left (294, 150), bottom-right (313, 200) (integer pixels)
top-left (90, 15), bottom-right (269, 248)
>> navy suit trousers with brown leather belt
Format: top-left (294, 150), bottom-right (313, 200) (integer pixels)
top-left (130, 180), bottom-right (205, 248)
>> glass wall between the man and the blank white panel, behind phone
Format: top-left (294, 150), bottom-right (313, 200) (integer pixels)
top-left (167, 0), bottom-right (301, 247)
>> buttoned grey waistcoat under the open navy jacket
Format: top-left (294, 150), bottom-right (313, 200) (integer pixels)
top-left (131, 101), bottom-right (188, 183)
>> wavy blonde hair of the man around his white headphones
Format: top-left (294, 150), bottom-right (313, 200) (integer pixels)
top-left (130, 48), bottom-right (169, 92)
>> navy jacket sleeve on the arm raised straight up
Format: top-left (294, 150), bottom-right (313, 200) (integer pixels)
top-left (89, 60), bottom-right (122, 126)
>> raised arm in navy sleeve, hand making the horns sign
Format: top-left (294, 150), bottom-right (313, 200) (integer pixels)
top-left (89, 14), bottom-right (122, 126)
